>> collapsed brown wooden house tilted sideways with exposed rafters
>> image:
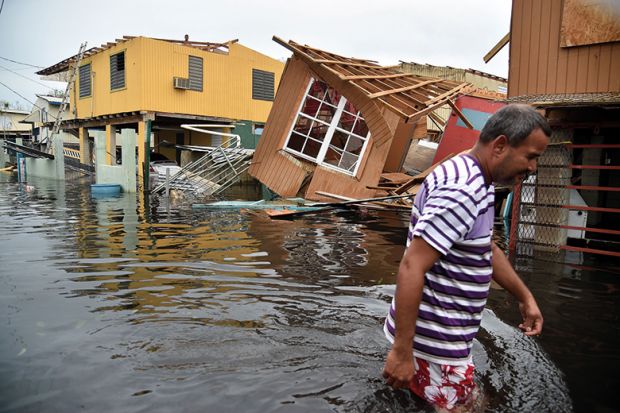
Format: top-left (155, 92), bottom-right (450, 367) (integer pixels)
top-left (249, 37), bottom-right (468, 200)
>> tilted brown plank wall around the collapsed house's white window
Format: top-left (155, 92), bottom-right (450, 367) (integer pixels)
top-left (250, 57), bottom-right (400, 200)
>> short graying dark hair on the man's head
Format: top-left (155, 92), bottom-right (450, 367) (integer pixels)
top-left (479, 104), bottom-right (551, 147)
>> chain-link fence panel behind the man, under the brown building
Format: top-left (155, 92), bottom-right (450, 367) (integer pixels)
top-left (513, 129), bottom-right (572, 256)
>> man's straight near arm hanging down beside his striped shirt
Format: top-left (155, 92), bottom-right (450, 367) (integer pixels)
top-left (383, 237), bottom-right (440, 388)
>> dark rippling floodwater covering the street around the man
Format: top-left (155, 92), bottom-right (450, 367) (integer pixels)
top-left (0, 174), bottom-right (620, 412)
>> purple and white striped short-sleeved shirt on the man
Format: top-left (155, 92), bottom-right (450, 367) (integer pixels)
top-left (383, 154), bottom-right (495, 365)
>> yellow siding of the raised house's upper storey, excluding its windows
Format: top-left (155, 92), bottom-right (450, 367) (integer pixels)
top-left (72, 37), bottom-right (284, 122)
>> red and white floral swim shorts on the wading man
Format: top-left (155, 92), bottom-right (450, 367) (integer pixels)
top-left (409, 357), bottom-right (476, 410)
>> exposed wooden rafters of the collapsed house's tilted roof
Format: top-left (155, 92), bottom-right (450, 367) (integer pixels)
top-left (273, 36), bottom-right (471, 120)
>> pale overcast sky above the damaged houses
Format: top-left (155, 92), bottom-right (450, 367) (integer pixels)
top-left (0, 0), bottom-right (511, 110)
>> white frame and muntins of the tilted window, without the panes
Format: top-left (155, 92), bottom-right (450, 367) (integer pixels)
top-left (283, 78), bottom-right (370, 176)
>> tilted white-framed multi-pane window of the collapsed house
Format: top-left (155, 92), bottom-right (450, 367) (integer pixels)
top-left (284, 79), bottom-right (370, 176)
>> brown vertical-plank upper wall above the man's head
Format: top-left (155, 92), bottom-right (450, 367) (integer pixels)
top-left (508, 0), bottom-right (620, 97)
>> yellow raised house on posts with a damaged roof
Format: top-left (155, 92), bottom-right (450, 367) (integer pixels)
top-left (37, 36), bottom-right (284, 187)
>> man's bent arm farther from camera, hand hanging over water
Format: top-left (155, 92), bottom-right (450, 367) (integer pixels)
top-left (492, 242), bottom-right (543, 336)
